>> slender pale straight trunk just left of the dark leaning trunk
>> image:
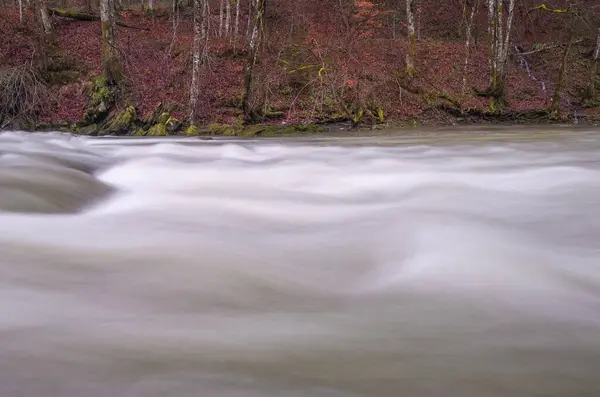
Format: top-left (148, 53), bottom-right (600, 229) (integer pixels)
top-left (189, 0), bottom-right (208, 123)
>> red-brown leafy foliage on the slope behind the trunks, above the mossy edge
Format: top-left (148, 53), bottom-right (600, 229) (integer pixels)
top-left (0, 0), bottom-right (596, 127)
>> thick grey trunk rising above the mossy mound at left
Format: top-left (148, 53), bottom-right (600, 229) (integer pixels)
top-left (100, 0), bottom-right (121, 85)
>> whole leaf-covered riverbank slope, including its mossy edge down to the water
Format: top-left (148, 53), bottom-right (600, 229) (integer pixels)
top-left (0, 2), bottom-right (600, 136)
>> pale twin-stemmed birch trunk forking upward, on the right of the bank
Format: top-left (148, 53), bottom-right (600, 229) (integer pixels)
top-left (487, 0), bottom-right (515, 112)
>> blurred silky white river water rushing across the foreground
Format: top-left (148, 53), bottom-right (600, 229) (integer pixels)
top-left (0, 133), bottom-right (600, 397)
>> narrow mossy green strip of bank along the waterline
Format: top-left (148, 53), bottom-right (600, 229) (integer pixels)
top-left (31, 106), bottom-right (600, 137)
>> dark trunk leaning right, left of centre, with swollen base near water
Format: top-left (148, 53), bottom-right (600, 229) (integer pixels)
top-left (242, 0), bottom-right (265, 123)
